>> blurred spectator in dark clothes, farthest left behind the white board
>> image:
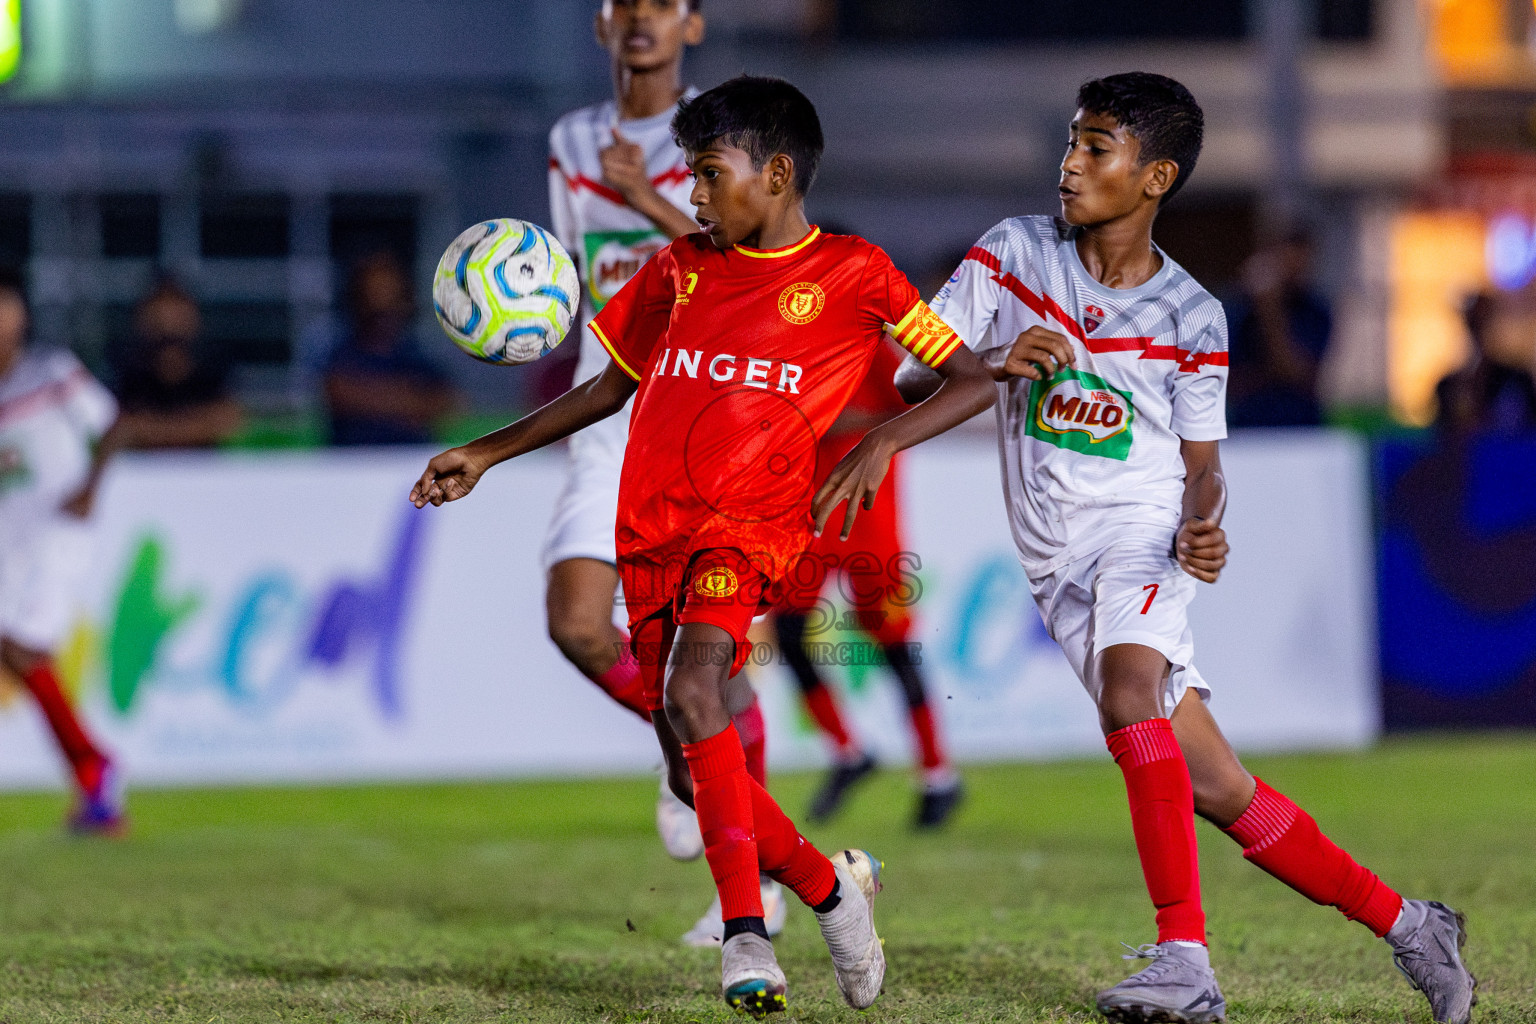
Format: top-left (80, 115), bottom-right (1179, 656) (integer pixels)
top-left (117, 279), bottom-right (243, 448)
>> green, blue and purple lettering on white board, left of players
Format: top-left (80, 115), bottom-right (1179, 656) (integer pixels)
top-left (65, 508), bottom-right (427, 720)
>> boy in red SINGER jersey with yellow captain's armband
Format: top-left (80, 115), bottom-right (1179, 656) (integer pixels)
top-left (412, 77), bottom-right (995, 1015)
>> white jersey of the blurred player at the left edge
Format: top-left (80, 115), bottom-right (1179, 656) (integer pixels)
top-left (0, 352), bottom-right (117, 530)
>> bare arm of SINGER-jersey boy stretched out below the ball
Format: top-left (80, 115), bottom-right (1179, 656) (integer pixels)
top-left (410, 361), bottom-right (636, 508)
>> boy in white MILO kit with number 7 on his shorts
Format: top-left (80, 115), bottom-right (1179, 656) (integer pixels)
top-left (884, 74), bottom-right (1476, 1022)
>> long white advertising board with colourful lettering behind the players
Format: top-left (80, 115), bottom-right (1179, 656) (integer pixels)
top-left (0, 434), bottom-right (1378, 788)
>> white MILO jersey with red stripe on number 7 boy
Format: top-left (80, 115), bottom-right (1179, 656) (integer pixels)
top-left (932, 216), bottom-right (1227, 577)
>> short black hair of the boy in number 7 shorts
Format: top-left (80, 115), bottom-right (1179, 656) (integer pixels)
top-left (1077, 71), bottom-right (1206, 203)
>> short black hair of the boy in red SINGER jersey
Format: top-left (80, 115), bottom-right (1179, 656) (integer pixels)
top-left (673, 75), bottom-right (825, 195)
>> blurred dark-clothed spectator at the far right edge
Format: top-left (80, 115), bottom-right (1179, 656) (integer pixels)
top-left (1435, 293), bottom-right (1536, 436)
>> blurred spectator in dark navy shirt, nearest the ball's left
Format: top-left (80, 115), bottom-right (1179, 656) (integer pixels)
top-left (317, 253), bottom-right (456, 445)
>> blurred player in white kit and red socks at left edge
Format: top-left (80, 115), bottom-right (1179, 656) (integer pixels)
top-left (0, 273), bottom-right (124, 834)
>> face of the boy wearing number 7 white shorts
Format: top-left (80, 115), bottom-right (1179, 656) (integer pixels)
top-left (1060, 111), bottom-right (1178, 227)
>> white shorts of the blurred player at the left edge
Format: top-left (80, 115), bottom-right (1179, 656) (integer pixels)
top-left (0, 516), bottom-right (95, 654)
